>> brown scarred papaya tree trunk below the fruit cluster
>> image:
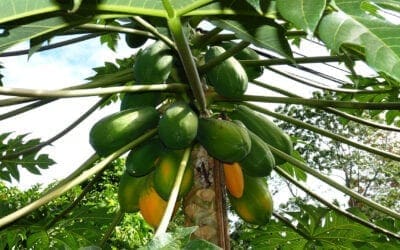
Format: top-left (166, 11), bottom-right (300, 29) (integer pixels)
top-left (183, 146), bottom-right (230, 249)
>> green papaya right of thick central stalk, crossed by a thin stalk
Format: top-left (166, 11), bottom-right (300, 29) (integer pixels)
top-left (204, 46), bottom-right (248, 98)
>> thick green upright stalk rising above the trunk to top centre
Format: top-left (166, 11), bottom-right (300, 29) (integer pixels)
top-left (168, 17), bottom-right (209, 116)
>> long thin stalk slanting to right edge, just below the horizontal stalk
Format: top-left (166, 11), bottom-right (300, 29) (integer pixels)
top-left (244, 103), bottom-right (400, 161)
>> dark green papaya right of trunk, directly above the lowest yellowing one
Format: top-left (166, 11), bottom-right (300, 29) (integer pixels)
top-left (239, 131), bottom-right (275, 177)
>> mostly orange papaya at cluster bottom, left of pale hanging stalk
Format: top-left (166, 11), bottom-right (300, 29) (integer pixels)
top-left (139, 175), bottom-right (168, 228)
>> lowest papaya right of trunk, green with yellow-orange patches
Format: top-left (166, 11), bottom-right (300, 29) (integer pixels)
top-left (228, 175), bottom-right (273, 225)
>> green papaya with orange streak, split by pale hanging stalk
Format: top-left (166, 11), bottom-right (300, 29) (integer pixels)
top-left (153, 150), bottom-right (194, 200)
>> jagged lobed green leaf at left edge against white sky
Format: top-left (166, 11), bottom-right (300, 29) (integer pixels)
top-left (0, 133), bottom-right (55, 182)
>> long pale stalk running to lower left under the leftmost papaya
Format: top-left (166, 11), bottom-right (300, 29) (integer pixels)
top-left (0, 129), bottom-right (157, 228)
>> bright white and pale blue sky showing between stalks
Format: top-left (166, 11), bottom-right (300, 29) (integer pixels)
top-left (0, 30), bottom-right (368, 207)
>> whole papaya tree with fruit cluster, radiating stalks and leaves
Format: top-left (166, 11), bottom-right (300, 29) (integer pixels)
top-left (0, 0), bottom-right (400, 249)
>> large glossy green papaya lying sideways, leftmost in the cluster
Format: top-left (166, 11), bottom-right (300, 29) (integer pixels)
top-left (89, 107), bottom-right (160, 156)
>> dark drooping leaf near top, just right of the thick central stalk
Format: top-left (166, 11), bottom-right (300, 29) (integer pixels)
top-left (211, 17), bottom-right (293, 59)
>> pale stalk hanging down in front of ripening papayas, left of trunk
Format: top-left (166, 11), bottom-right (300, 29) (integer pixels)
top-left (154, 148), bottom-right (192, 237)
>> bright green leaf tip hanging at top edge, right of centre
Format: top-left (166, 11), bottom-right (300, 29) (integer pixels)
top-left (276, 0), bottom-right (326, 34)
